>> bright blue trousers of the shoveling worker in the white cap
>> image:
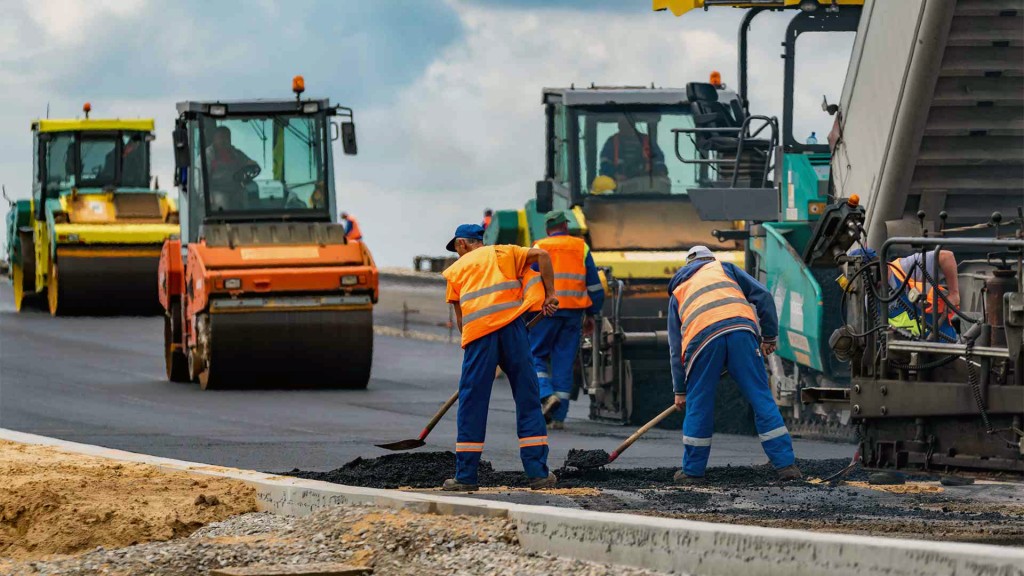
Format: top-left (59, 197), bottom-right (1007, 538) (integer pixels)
top-left (674, 330), bottom-right (796, 477)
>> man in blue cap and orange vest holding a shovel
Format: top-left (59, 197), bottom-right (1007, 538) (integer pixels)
top-left (441, 224), bottom-right (558, 492)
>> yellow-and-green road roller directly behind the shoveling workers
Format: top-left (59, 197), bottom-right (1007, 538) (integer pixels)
top-left (484, 87), bottom-right (743, 425)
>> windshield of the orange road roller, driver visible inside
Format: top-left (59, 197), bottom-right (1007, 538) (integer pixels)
top-left (203, 115), bottom-right (328, 215)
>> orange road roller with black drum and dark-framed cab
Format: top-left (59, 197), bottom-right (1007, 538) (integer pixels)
top-left (158, 77), bottom-right (378, 389)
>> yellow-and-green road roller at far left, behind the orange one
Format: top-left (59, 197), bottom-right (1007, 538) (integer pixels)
top-left (5, 102), bottom-right (178, 316)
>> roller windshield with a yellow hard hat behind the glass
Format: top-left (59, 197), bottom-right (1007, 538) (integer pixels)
top-left (577, 107), bottom-right (697, 195)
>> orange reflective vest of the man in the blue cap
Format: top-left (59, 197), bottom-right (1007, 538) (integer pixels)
top-left (442, 246), bottom-right (543, 347)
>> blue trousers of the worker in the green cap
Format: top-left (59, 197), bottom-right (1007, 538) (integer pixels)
top-left (529, 310), bottom-right (584, 422)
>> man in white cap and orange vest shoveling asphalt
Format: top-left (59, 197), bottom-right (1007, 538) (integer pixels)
top-left (669, 246), bottom-right (802, 484)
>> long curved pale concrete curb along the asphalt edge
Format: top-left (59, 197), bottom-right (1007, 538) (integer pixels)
top-left (0, 428), bottom-right (1024, 576)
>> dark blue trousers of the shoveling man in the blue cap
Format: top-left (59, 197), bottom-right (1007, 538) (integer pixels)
top-left (455, 319), bottom-right (548, 484)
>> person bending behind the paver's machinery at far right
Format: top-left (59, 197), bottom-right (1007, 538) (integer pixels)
top-left (889, 250), bottom-right (959, 342)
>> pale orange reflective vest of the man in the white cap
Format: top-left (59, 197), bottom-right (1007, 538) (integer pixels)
top-left (672, 260), bottom-right (757, 366)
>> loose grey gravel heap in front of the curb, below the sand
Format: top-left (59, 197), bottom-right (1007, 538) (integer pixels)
top-left (5, 506), bottom-right (671, 576)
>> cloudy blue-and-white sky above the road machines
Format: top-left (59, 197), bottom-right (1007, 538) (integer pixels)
top-left (0, 0), bottom-right (850, 265)
